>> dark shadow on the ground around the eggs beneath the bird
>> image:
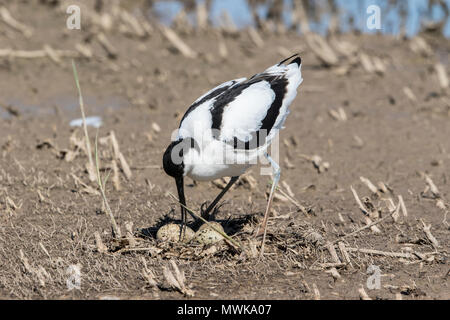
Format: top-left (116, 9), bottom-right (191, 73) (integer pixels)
top-left (138, 205), bottom-right (258, 239)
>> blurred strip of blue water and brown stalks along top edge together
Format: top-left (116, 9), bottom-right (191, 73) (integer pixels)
top-left (134, 0), bottom-right (450, 37)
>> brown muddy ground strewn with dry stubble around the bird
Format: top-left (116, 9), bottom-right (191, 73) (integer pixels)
top-left (0, 1), bottom-right (450, 299)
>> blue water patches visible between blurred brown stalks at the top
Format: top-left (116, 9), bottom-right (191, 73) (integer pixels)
top-left (153, 0), bottom-right (450, 37)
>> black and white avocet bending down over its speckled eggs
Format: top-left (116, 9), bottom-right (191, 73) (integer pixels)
top-left (163, 54), bottom-right (303, 245)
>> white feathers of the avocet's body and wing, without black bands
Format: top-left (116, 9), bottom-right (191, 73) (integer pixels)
top-left (177, 55), bottom-right (303, 181)
